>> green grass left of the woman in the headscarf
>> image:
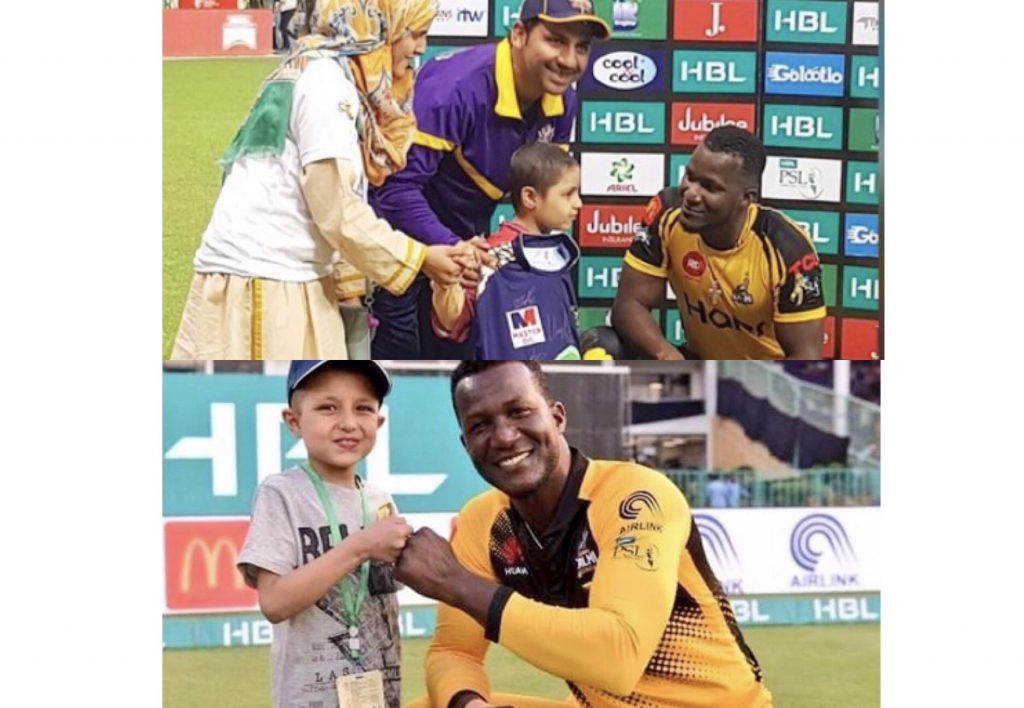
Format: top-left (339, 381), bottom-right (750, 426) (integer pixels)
top-left (164, 58), bottom-right (279, 359)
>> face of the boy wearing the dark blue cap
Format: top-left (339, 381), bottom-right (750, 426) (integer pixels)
top-left (284, 369), bottom-right (384, 473)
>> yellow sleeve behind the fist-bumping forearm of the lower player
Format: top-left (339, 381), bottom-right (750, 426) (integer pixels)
top-left (426, 502), bottom-right (497, 706)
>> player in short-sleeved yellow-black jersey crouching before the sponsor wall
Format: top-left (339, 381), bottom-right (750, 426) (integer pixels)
top-left (611, 125), bottom-right (825, 360)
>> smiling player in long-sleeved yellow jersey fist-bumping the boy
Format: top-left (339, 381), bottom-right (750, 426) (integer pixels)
top-left (395, 361), bottom-right (771, 708)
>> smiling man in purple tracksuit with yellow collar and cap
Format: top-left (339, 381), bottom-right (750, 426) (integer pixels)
top-left (371, 0), bottom-right (610, 359)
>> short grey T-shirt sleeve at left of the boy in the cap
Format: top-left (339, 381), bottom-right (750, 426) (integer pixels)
top-left (238, 483), bottom-right (296, 588)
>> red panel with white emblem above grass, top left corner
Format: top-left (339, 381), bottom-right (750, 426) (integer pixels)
top-left (164, 9), bottom-right (273, 56)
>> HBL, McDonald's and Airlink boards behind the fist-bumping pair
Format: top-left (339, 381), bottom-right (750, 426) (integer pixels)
top-left (163, 374), bottom-right (881, 647)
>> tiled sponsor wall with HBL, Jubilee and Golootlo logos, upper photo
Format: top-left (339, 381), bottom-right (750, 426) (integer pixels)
top-left (427, 0), bottom-right (882, 359)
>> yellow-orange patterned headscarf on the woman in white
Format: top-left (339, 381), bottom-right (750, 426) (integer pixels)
top-left (284, 0), bottom-right (437, 186)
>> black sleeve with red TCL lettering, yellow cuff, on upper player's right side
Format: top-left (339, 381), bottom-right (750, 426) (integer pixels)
top-left (772, 217), bottom-right (825, 324)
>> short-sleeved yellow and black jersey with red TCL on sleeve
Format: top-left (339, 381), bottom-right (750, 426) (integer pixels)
top-left (626, 188), bottom-right (825, 359)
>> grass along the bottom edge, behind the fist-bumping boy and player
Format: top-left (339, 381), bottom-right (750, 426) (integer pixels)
top-left (164, 624), bottom-right (881, 708)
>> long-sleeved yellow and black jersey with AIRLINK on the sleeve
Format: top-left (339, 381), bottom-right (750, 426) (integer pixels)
top-left (427, 450), bottom-right (771, 708)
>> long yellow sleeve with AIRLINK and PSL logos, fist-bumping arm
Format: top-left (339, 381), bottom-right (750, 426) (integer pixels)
top-left (500, 467), bottom-right (690, 695)
